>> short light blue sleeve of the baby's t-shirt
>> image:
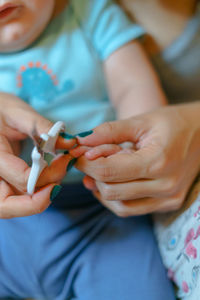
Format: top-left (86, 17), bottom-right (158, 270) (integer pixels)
top-left (72, 0), bottom-right (145, 60)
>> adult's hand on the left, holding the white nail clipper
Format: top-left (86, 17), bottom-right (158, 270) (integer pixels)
top-left (0, 93), bottom-right (75, 218)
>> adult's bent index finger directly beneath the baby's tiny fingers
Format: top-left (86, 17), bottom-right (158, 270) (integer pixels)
top-left (76, 147), bottom-right (155, 182)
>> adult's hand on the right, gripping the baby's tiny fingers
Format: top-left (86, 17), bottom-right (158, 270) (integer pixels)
top-left (71, 102), bottom-right (200, 217)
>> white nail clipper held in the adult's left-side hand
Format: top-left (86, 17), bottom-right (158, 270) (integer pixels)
top-left (27, 121), bottom-right (65, 195)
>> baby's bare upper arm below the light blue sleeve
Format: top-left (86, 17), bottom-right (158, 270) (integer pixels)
top-left (104, 41), bottom-right (167, 119)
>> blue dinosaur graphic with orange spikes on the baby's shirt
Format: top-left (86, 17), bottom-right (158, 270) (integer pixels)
top-left (18, 63), bottom-right (74, 106)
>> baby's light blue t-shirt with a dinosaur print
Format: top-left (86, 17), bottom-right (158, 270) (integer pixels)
top-left (0, 0), bottom-right (144, 180)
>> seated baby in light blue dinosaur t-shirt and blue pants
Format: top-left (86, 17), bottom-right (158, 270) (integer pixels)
top-left (0, 0), bottom-right (174, 300)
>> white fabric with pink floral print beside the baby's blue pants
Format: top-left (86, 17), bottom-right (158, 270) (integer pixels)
top-left (155, 179), bottom-right (200, 300)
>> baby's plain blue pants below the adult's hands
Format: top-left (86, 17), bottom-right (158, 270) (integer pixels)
top-left (0, 185), bottom-right (175, 300)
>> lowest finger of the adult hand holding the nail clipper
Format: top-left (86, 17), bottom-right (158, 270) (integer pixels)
top-left (0, 180), bottom-right (58, 219)
